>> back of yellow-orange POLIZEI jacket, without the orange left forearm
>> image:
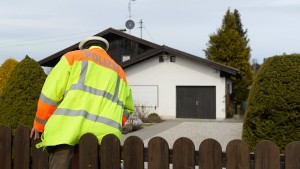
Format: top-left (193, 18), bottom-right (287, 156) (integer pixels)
top-left (35, 47), bottom-right (133, 146)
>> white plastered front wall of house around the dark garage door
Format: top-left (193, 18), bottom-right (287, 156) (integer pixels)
top-left (125, 56), bottom-right (225, 120)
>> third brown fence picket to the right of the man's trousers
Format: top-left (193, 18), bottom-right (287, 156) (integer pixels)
top-left (122, 136), bottom-right (144, 169)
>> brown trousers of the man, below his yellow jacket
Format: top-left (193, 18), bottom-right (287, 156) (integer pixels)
top-left (47, 144), bottom-right (74, 169)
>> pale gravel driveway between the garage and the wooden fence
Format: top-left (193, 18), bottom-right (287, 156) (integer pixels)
top-left (122, 119), bottom-right (243, 151)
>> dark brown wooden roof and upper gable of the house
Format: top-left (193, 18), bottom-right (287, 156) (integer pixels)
top-left (39, 28), bottom-right (238, 77)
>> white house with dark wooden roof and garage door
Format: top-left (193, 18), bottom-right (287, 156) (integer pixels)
top-left (39, 28), bottom-right (238, 120)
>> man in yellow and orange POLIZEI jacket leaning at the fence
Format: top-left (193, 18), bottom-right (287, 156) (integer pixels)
top-left (30, 36), bottom-right (134, 169)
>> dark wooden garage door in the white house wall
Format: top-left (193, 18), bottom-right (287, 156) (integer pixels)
top-left (176, 86), bottom-right (216, 119)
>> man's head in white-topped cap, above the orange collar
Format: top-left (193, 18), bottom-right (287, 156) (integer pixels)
top-left (78, 36), bottom-right (109, 51)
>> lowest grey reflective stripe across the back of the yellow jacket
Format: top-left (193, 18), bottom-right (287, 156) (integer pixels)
top-left (54, 108), bottom-right (122, 131)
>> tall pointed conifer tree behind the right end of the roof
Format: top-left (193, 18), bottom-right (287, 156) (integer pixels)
top-left (204, 9), bottom-right (253, 103)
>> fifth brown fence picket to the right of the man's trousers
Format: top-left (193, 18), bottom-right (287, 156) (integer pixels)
top-left (173, 137), bottom-right (195, 169)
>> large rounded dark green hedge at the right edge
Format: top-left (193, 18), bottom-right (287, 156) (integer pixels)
top-left (242, 54), bottom-right (300, 152)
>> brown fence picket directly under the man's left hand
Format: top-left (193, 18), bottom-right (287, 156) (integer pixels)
top-left (31, 140), bottom-right (49, 169)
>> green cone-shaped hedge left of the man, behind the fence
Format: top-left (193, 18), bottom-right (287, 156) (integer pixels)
top-left (0, 56), bottom-right (46, 129)
